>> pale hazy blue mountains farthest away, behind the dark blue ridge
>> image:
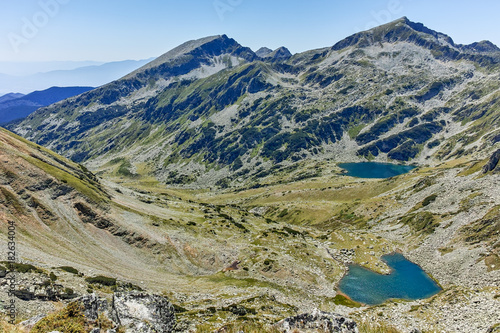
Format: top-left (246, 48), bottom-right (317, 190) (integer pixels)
top-left (0, 58), bottom-right (153, 95)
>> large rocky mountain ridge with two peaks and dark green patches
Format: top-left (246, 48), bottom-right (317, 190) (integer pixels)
top-left (10, 18), bottom-right (500, 185)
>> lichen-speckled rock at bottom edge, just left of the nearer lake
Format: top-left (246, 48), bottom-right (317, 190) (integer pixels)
top-left (276, 310), bottom-right (358, 333)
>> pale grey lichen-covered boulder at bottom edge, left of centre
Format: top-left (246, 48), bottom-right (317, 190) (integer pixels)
top-left (111, 292), bottom-right (175, 333)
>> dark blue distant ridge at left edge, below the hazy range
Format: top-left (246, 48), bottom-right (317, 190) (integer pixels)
top-left (0, 87), bottom-right (94, 125)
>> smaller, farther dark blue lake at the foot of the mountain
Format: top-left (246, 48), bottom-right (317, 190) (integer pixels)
top-left (339, 162), bottom-right (416, 178)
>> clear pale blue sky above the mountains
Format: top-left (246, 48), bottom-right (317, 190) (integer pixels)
top-left (0, 0), bottom-right (500, 61)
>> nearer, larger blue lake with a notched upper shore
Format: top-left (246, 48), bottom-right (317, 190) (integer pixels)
top-left (339, 253), bottom-right (441, 305)
